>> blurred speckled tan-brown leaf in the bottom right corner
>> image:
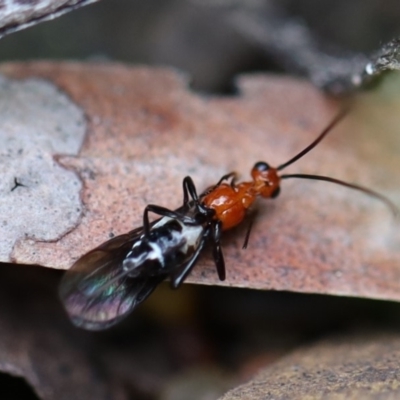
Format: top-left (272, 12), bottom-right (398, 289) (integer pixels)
top-left (220, 333), bottom-right (400, 400)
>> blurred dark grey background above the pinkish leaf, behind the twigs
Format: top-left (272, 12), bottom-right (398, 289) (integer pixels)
top-left (0, 0), bottom-right (400, 93)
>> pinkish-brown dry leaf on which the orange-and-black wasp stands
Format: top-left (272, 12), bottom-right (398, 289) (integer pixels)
top-left (0, 63), bottom-right (400, 300)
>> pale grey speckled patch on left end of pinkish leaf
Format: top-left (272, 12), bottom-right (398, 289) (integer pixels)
top-left (0, 76), bottom-right (86, 263)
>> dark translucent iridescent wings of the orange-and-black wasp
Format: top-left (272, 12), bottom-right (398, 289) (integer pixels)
top-left (59, 228), bottom-right (165, 330)
